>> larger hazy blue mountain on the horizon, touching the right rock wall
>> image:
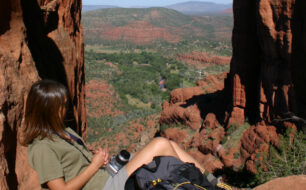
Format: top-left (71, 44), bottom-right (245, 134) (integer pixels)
top-left (166, 1), bottom-right (233, 16)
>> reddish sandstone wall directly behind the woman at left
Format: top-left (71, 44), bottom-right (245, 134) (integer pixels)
top-left (0, 0), bottom-right (86, 190)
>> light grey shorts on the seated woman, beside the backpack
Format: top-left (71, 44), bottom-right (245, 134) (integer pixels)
top-left (102, 167), bottom-right (129, 190)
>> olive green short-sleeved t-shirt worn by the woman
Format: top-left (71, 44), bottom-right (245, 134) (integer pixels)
top-left (28, 128), bottom-right (109, 190)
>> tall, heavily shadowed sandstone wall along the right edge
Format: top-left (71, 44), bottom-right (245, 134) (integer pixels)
top-left (227, 0), bottom-right (306, 123)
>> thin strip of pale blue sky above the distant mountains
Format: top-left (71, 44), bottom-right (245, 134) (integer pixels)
top-left (83, 0), bottom-right (233, 7)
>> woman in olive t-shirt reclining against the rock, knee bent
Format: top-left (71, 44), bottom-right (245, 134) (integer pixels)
top-left (23, 80), bottom-right (205, 190)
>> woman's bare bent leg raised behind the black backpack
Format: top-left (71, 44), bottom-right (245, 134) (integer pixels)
top-left (126, 137), bottom-right (205, 175)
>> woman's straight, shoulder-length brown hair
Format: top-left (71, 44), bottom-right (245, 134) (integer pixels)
top-left (22, 80), bottom-right (68, 145)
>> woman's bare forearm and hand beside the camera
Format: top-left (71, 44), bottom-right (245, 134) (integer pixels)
top-left (47, 148), bottom-right (108, 190)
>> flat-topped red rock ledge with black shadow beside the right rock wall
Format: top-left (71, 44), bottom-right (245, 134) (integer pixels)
top-left (160, 73), bottom-right (226, 130)
